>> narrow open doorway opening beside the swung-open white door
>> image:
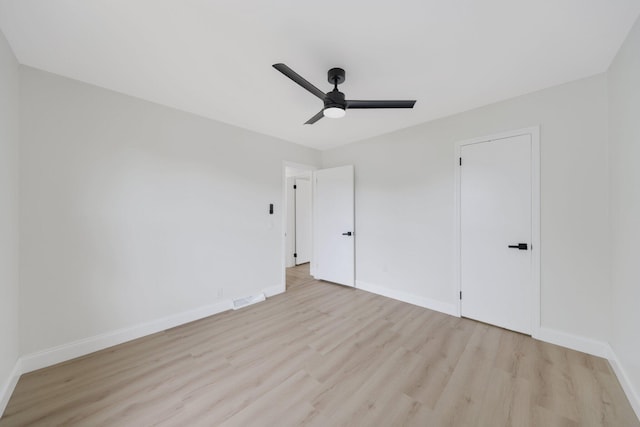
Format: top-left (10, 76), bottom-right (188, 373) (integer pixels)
top-left (284, 163), bottom-right (315, 289)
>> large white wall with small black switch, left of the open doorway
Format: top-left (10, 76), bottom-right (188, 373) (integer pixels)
top-left (20, 68), bottom-right (319, 354)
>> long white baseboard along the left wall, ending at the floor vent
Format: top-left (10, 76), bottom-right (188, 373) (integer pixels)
top-left (21, 300), bottom-right (232, 373)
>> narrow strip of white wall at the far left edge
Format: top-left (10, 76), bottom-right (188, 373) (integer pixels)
top-left (0, 32), bottom-right (20, 414)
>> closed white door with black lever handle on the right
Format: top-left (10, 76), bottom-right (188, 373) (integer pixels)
top-left (460, 135), bottom-right (533, 334)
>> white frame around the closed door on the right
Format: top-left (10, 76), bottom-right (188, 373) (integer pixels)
top-left (454, 126), bottom-right (541, 337)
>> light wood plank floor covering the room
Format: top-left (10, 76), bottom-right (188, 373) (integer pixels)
top-left (0, 265), bottom-right (640, 427)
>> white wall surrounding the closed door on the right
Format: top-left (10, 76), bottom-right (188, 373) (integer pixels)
top-left (323, 75), bottom-right (610, 341)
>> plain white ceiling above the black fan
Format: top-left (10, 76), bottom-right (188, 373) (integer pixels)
top-left (0, 0), bottom-right (640, 149)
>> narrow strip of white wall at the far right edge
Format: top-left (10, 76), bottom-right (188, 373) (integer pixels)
top-left (608, 15), bottom-right (640, 416)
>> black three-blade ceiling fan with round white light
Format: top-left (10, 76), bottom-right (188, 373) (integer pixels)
top-left (273, 64), bottom-right (416, 125)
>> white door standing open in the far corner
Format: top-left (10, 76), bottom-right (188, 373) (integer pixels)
top-left (313, 165), bottom-right (355, 286)
